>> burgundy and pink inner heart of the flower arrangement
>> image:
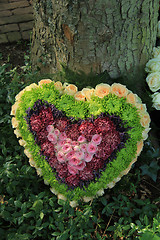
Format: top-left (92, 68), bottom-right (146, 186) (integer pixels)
top-left (28, 100), bottom-right (127, 187)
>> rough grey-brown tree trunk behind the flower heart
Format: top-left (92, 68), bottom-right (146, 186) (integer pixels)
top-left (32, 0), bottom-right (159, 89)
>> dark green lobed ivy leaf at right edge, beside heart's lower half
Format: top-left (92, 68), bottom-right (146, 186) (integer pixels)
top-left (140, 160), bottom-right (160, 182)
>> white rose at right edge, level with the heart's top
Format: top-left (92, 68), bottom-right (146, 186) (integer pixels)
top-left (146, 72), bottom-right (160, 92)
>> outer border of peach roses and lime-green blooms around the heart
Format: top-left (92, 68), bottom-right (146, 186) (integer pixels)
top-left (11, 79), bottom-right (150, 206)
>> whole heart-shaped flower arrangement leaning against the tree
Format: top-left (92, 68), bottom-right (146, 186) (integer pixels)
top-left (11, 79), bottom-right (150, 206)
